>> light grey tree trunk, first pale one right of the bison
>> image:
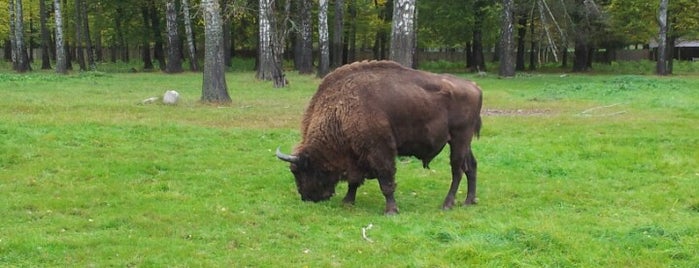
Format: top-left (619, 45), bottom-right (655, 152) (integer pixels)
top-left (498, 0), bottom-right (515, 77)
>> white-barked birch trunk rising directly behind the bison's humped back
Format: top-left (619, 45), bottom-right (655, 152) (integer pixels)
top-left (389, 0), bottom-right (416, 67)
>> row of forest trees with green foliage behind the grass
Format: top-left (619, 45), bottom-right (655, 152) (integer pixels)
top-left (0, 0), bottom-right (699, 77)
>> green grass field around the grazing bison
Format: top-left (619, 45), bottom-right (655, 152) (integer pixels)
top-left (0, 72), bottom-right (699, 267)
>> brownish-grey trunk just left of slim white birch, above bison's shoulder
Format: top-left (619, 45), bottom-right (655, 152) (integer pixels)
top-left (296, 0), bottom-right (313, 74)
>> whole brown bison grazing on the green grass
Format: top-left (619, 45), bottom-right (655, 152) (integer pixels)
top-left (276, 61), bottom-right (482, 214)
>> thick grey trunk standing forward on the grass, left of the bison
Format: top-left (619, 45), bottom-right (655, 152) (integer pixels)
top-left (201, 0), bottom-right (231, 103)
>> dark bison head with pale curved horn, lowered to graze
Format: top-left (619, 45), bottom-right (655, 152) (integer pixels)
top-left (276, 148), bottom-right (340, 202)
